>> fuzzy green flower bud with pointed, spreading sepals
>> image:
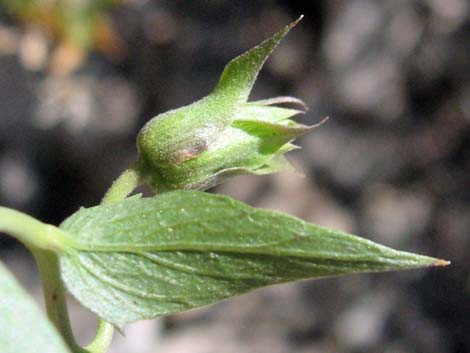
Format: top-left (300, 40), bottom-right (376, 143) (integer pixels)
top-left (137, 17), bottom-right (322, 191)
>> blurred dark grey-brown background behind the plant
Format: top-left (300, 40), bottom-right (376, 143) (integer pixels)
top-left (0, 0), bottom-right (470, 353)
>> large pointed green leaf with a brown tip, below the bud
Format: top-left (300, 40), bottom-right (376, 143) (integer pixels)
top-left (60, 191), bottom-right (443, 327)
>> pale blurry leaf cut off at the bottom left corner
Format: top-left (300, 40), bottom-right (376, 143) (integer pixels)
top-left (0, 262), bottom-right (70, 353)
